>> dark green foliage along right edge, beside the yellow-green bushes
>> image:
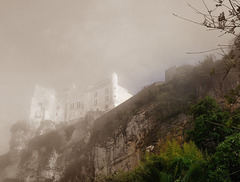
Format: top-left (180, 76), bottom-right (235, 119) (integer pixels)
top-left (189, 96), bottom-right (240, 182)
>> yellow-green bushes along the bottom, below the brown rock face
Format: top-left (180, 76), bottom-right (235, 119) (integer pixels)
top-left (96, 141), bottom-right (205, 182)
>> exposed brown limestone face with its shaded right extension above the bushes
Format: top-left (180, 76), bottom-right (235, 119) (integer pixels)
top-left (93, 110), bottom-right (191, 176)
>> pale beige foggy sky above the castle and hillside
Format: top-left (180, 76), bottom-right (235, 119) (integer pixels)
top-left (0, 0), bottom-right (234, 154)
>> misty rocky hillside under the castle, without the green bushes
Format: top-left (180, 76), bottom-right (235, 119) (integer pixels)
top-left (0, 59), bottom-right (239, 181)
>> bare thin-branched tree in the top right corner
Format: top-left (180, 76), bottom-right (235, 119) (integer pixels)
top-left (174, 0), bottom-right (240, 75)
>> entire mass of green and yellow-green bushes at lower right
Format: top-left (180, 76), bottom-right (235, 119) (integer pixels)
top-left (96, 96), bottom-right (240, 182)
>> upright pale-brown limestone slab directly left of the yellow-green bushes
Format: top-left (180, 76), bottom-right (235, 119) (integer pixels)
top-left (93, 111), bottom-right (149, 176)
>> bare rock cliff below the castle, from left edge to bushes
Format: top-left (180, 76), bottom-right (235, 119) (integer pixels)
top-left (1, 98), bottom-right (192, 182)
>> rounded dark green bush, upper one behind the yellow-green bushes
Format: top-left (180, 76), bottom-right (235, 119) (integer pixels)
top-left (188, 96), bottom-right (236, 153)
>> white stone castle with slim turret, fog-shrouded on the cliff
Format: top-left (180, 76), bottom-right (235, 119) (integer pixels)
top-left (29, 73), bottom-right (132, 123)
